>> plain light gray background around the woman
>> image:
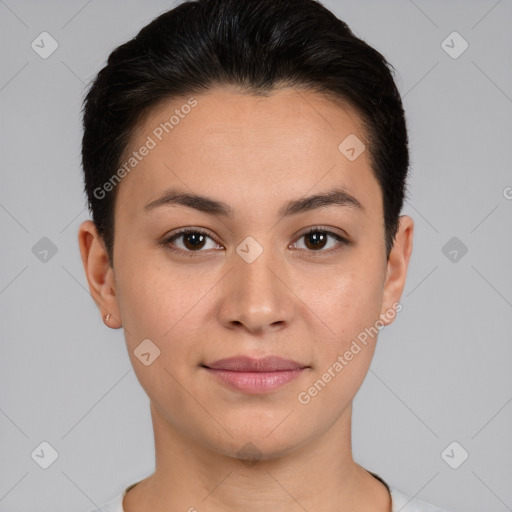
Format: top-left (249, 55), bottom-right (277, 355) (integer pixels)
top-left (0, 0), bottom-right (512, 512)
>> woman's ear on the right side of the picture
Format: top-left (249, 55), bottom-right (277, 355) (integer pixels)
top-left (381, 215), bottom-right (414, 325)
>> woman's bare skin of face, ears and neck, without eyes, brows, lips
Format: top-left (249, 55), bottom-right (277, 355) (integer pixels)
top-left (79, 88), bottom-right (414, 512)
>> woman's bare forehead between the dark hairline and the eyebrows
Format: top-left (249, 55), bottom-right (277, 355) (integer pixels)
top-left (118, 88), bottom-right (380, 222)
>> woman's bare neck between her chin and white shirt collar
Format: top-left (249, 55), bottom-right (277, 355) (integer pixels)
top-left (123, 404), bottom-right (391, 512)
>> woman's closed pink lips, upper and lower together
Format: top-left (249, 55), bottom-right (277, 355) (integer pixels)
top-left (202, 356), bottom-right (309, 394)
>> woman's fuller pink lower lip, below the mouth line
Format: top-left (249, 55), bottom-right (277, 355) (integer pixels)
top-left (205, 368), bottom-right (306, 394)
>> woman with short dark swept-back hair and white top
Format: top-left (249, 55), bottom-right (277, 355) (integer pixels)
top-left (79, 0), bottom-right (452, 512)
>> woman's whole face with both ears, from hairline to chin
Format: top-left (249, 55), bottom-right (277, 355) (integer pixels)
top-left (80, 89), bottom-right (412, 458)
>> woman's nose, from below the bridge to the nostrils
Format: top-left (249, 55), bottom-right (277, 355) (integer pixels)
top-left (218, 240), bottom-right (295, 335)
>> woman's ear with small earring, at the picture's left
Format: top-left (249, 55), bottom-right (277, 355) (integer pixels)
top-left (78, 220), bottom-right (122, 329)
